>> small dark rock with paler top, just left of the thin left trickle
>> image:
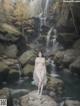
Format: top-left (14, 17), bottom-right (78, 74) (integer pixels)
top-left (7, 69), bottom-right (19, 82)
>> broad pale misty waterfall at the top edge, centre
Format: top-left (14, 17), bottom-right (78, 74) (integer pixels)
top-left (29, 0), bottom-right (50, 17)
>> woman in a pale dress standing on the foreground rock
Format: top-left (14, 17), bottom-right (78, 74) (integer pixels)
top-left (33, 52), bottom-right (47, 95)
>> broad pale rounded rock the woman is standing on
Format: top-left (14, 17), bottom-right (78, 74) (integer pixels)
top-left (20, 91), bottom-right (58, 106)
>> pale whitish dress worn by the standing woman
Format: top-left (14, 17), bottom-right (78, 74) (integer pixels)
top-left (33, 57), bottom-right (47, 86)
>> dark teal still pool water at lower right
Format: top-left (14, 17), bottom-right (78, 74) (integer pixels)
top-left (59, 71), bottom-right (80, 100)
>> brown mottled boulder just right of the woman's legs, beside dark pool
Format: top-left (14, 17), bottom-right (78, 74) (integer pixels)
top-left (46, 77), bottom-right (64, 95)
